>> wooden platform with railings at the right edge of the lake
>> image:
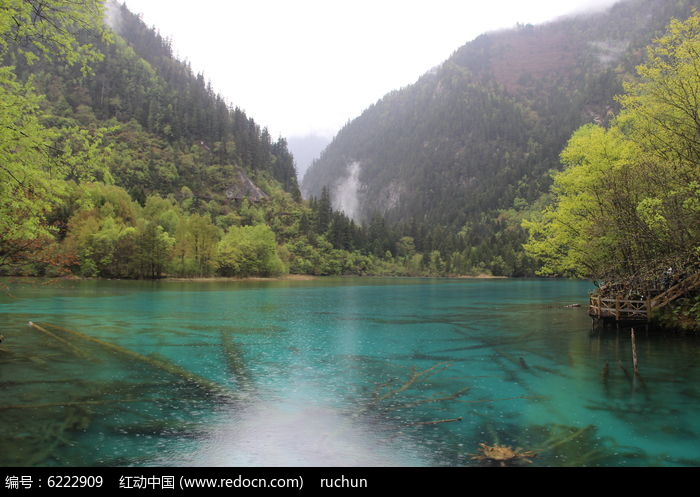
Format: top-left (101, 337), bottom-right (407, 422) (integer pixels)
top-left (588, 272), bottom-right (700, 322)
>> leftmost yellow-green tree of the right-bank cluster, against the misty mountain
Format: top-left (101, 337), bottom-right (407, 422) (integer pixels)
top-left (524, 125), bottom-right (636, 277)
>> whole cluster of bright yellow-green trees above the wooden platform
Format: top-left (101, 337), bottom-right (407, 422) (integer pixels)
top-left (525, 15), bottom-right (700, 280)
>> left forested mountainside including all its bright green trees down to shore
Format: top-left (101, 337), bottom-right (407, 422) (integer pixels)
top-left (0, 0), bottom-right (460, 278)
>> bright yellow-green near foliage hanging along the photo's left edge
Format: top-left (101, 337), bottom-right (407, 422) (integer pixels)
top-left (0, 0), bottom-right (102, 264)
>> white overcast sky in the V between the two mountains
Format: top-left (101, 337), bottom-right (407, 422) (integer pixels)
top-left (124, 0), bottom-right (615, 137)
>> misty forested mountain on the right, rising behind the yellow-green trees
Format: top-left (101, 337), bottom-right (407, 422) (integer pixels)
top-left (303, 0), bottom-right (700, 274)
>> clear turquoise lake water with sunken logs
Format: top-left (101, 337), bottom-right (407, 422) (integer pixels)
top-left (0, 279), bottom-right (700, 466)
